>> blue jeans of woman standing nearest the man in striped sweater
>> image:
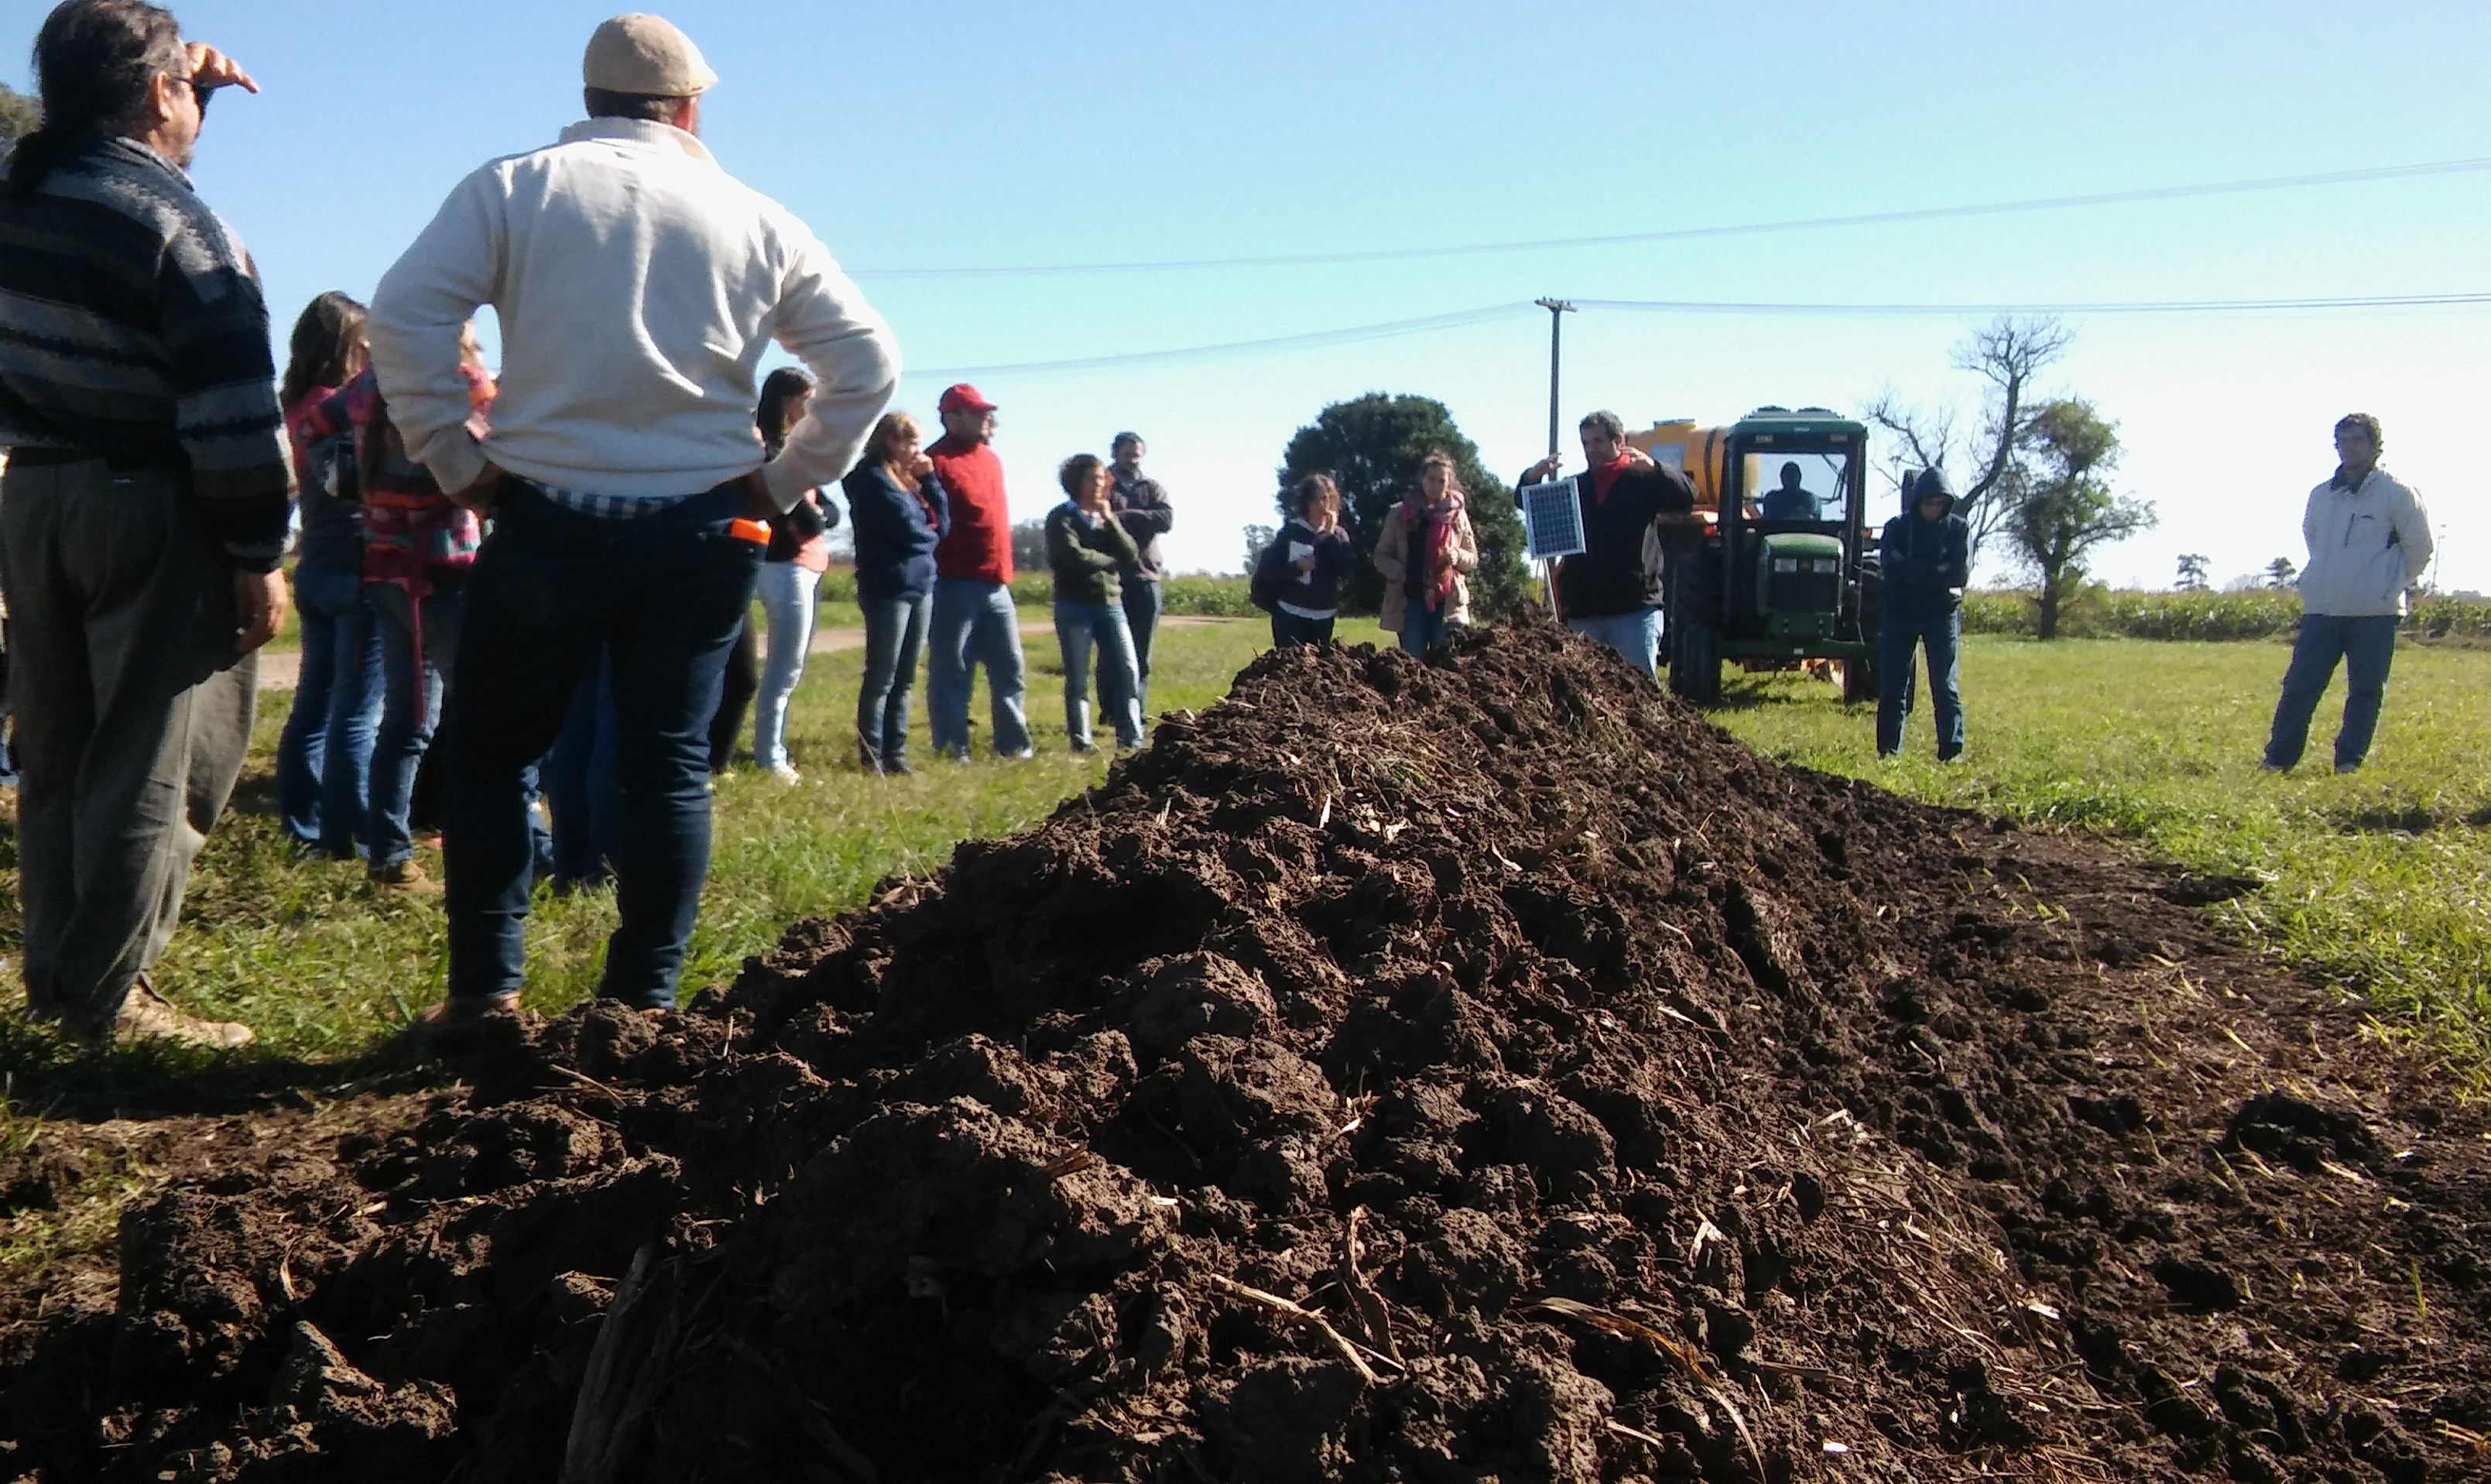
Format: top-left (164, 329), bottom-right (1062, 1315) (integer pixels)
top-left (276, 563), bottom-right (381, 859)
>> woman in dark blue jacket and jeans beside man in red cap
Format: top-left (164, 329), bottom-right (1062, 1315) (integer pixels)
top-left (839, 413), bottom-right (951, 774)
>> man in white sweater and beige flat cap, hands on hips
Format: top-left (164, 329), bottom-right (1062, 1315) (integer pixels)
top-left (368, 15), bottom-right (899, 1031)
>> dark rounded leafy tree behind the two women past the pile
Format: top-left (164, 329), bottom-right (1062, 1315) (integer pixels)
top-left (1273, 391), bottom-right (1530, 620)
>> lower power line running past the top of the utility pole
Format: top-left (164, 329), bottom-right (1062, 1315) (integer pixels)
top-left (910, 291), bottom-right (2491, 381)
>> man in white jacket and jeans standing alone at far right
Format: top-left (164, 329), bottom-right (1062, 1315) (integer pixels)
top-left (2264, 413), bottom-right (2431, 772)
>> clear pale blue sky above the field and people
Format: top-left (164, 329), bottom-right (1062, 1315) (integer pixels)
top-left (24, 0), bottom-right (2491, 590)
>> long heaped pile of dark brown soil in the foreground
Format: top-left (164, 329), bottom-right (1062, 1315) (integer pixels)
top-left (0, 628), bottom-right (2491, 1484)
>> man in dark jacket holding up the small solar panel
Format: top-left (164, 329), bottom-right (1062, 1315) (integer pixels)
top-left (1515, 411), bottom-right (1696, 682)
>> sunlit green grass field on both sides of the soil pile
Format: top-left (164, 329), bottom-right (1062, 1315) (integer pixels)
top-left (0, 615), bottom-right (2491, 1073)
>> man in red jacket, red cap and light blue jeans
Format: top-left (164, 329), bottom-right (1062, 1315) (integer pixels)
top-left (927, 381), bottom-right (1031, 762)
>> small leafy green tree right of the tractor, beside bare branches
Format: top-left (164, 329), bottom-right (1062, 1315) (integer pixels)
top-left (1998, 396), bottom-right (2157, 640)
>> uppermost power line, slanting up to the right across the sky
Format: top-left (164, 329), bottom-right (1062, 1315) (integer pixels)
top-left (852, 157), bottom-right (2491, 279)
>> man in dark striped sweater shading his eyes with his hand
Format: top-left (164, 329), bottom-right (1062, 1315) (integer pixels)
top-left (0, 0), bottom-right (292, 1046)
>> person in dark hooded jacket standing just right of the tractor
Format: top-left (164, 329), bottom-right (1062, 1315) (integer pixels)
top-left (1876, 468), bottom-right (1973, 762)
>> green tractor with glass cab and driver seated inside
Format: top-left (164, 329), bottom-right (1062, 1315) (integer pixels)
top-left (1626, 406), bottom-right (1878, 704)
